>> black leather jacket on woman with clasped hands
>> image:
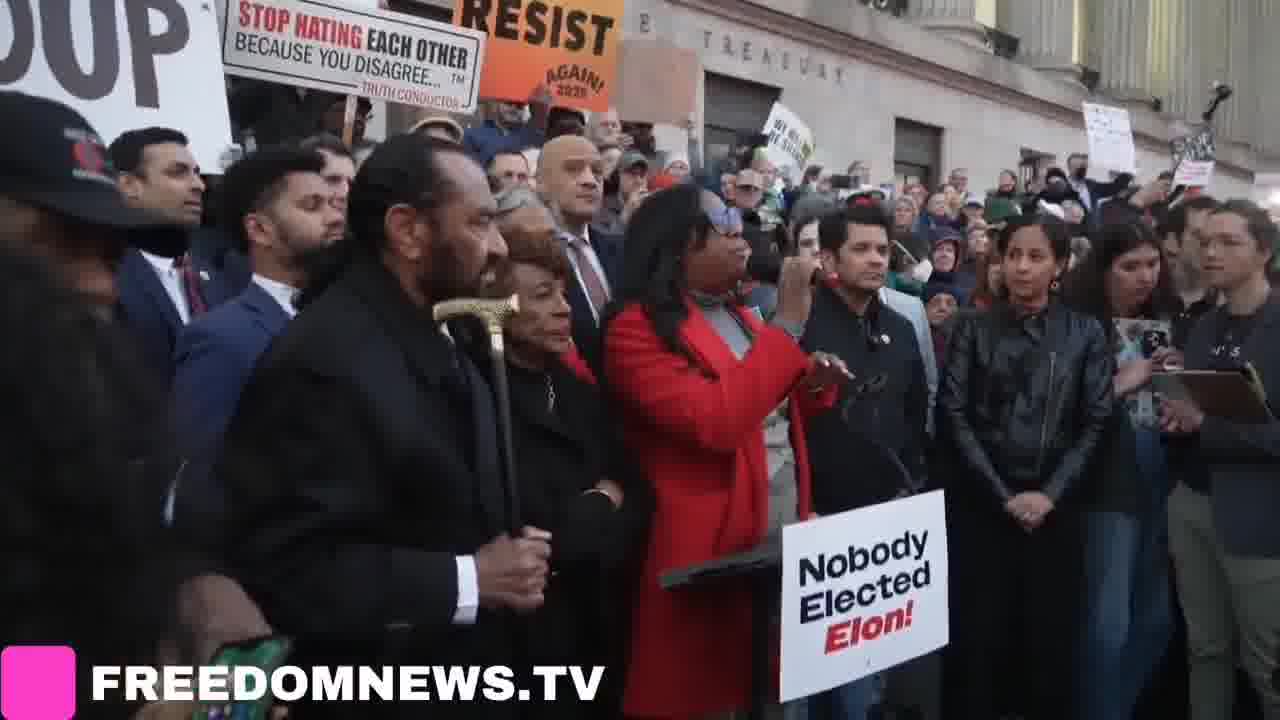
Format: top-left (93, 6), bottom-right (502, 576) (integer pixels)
top-left (938, 301), bottom-right (1115, 505)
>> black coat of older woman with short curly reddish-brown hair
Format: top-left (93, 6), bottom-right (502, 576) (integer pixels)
top-left (508, 365), bottom-right (648, 720)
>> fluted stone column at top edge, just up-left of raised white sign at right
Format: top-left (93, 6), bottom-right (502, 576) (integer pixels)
top-left (1001, 0), bottom-right (1080, 83)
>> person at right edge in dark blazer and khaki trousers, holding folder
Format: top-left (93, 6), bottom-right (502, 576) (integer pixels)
top-left (1161, 200), bottom-right (1280, 720)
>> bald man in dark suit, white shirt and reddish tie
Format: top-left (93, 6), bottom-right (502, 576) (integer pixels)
top-left (538, 135), bottom-right (622, 370)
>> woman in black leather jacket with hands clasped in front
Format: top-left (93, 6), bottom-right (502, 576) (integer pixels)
top-left (938, 215), bottom-right (1115, 720)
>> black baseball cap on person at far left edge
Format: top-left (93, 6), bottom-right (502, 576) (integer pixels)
top-left (0, 91), bottom-right (169, 229)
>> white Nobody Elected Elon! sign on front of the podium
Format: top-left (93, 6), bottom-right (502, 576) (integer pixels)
top-left (781, 491), bottom-right (950, 702)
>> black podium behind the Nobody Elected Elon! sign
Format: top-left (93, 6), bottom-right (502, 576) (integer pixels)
top-left (658, 533), bottom-right (782, 720)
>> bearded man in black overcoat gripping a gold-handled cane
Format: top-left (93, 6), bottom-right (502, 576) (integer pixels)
top-left (215, 135), bottom-right (550, 720)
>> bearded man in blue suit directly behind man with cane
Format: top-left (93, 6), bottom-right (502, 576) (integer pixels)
top-left (173, 147), bottom-right (344, 533)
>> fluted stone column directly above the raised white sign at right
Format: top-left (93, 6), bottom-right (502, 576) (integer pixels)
top-left (1089, 0), bottom-right (1152, 105)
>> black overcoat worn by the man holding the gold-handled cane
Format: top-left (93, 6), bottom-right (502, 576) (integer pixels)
top-left (216, 259), bottom-right (516, 720)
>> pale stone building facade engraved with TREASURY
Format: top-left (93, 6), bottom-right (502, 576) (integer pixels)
top-left (390, 0), bottom-right (1280, 196)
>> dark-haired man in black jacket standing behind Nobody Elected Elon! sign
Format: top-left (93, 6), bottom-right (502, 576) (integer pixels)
top-left (801, 205), bottom-right (929, 720)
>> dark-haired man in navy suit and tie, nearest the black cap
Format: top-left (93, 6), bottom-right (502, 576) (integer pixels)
top-left (108, 127), bottom-right (243, 387)
